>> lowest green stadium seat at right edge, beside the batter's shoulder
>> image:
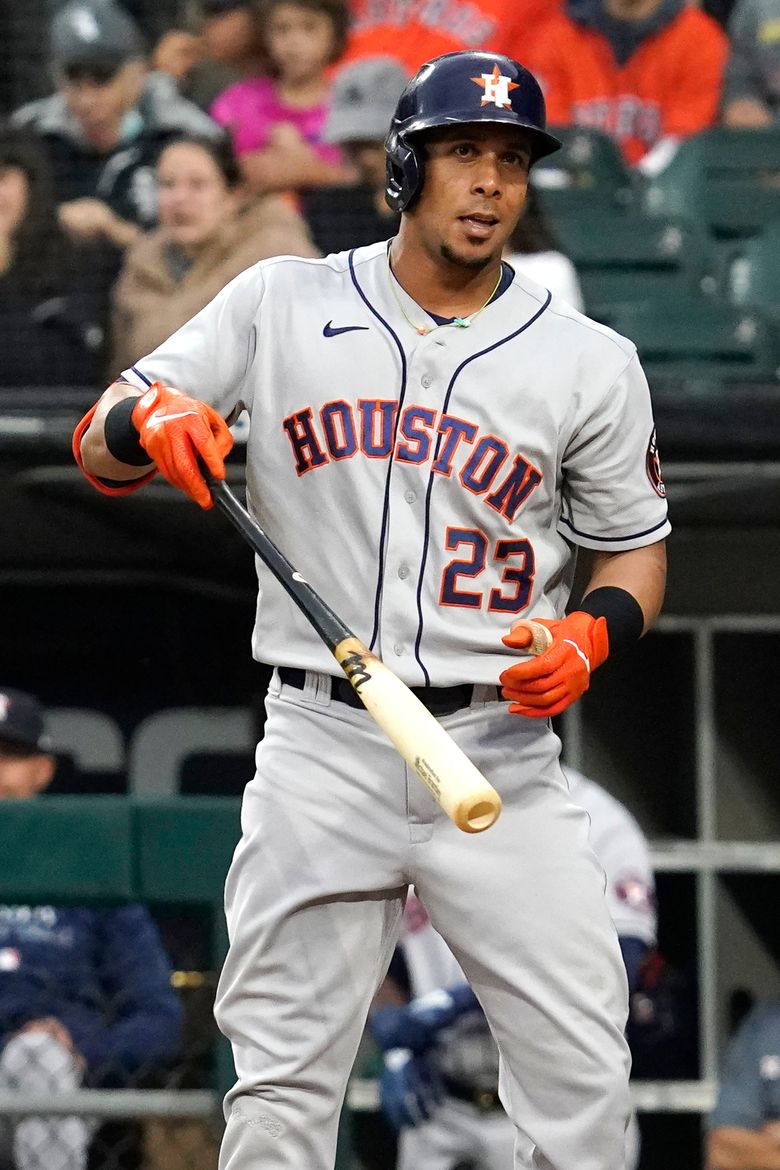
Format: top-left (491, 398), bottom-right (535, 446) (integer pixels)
top-left (610, 293), bottom-right (780, 387)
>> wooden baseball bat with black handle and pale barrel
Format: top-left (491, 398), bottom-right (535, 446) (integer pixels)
top-left (206, 474), bottom-right (548, 833)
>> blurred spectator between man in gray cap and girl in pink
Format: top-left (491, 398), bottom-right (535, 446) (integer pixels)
top-left (152, 0), bottom-right (273, 110)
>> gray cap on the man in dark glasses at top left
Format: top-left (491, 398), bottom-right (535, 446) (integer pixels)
top-left (49, 0), bottom-right (146, 74)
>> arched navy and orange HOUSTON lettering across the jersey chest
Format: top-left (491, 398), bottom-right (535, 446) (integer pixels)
top-left (282, 398), bottom-right (541, 522)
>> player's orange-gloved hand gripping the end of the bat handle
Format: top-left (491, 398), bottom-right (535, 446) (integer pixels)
top-left (131, 381), bottom-right (233, 508)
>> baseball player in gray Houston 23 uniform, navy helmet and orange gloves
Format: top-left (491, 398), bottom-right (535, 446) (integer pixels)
top-left (74, 53), bottom-right (669, 1170)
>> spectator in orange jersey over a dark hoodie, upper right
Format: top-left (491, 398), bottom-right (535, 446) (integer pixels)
top-left (524, 0), bottom-right (729, 174)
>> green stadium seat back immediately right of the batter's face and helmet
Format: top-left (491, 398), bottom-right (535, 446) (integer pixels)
top-left (531, 126), bottom-right (635, 218)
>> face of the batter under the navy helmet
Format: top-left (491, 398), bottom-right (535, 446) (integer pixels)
top-left (407, 123), bottom-right (531, 268)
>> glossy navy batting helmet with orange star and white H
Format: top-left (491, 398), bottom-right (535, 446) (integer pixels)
top-left (385, 51), bottom-right (561, 212)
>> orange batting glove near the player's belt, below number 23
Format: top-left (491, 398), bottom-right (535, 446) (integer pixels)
top-left (499, 610), bottom-right (609, 718)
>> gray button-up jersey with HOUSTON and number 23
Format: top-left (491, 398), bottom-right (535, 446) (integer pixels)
top-left (124, 243), bottom-right (669, 686)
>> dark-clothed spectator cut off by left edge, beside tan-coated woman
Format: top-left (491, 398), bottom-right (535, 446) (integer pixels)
top-left (0, 130), bottom-right (109, 386)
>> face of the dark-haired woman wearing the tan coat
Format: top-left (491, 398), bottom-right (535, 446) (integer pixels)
top-left (157, 143), bottom-right (240, 252)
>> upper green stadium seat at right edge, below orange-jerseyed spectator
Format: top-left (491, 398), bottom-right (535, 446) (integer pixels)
top-left (643, 126), bottom-right (780, 239)
